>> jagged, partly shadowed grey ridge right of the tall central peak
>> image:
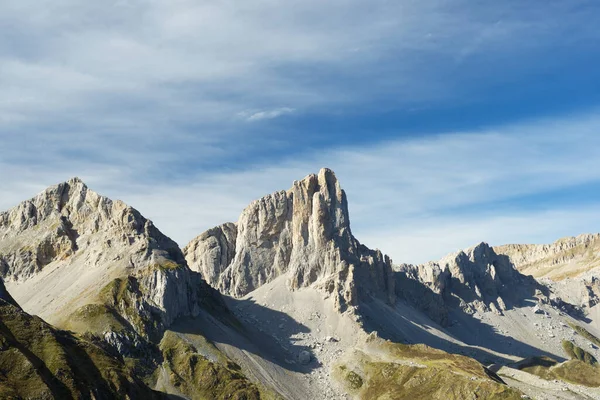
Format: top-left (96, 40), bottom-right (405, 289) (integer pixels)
top-left (395, 243), bottom-right (563, 324)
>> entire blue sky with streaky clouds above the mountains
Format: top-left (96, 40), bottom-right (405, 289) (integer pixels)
top-left (0, 0), bottom-right (600, 263)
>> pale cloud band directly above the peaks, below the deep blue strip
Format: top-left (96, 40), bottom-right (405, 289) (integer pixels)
top-left (0, 113), bottom-right (600, 262)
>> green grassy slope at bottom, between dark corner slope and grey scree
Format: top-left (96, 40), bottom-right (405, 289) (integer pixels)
top-left (160, 331), bottom-right (274, 400)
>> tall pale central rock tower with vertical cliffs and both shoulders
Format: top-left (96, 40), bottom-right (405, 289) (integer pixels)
top-left (185, 169), bottom-right (395, 310)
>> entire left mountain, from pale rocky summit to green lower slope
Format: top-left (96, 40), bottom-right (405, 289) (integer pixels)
top-left (0, 179), bottom-right (288, 399)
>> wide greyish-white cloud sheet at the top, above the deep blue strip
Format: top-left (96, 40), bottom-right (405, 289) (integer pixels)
top-left (0, 0), bottom-right (600, 134)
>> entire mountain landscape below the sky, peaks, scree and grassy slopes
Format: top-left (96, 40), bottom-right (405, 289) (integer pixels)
top-left (0, 169), bottom-right (600, 400)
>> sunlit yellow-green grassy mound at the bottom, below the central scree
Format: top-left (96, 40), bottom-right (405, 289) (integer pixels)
top-left (335, 342), bottom-right (522, 400)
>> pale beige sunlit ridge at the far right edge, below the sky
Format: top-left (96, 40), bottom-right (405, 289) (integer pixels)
top-left (494, 234), bottom-right (600, 281)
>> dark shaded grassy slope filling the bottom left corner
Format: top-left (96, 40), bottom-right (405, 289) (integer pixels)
top-left (0, 300), bottom-right (159, 399)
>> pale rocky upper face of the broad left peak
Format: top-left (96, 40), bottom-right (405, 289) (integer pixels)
top-left (0, 178), bottom-right (214, 342)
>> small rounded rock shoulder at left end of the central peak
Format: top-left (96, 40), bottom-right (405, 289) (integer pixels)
top-left (183, 223), bottom-right (237, 286)
